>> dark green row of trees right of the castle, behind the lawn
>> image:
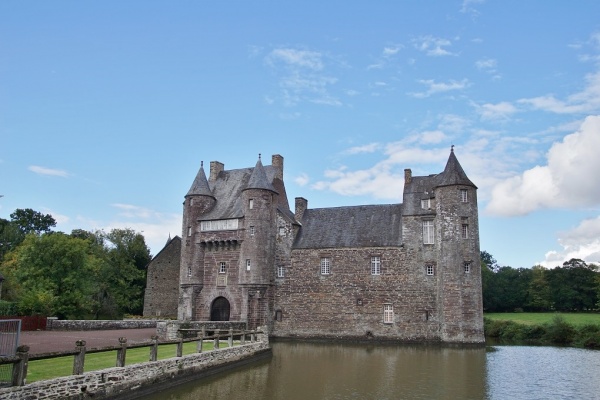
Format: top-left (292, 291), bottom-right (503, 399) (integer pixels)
top-left (481, 251), bottom-right (600, 312)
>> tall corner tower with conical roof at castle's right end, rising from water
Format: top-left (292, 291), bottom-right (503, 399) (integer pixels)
top-left (434, 146), bottom-right (485, 343)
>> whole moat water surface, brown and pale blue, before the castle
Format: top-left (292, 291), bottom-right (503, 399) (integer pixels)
top-left (144, 342), bottom-right (600, 400)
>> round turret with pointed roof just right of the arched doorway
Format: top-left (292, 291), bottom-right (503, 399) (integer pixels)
top-left (238, 155), bottom-right (278, 328)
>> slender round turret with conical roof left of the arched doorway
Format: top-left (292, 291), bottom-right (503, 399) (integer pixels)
top-left (178, 163), bottom-right (216, 320)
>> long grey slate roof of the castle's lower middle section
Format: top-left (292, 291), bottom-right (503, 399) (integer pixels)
top-left (293, 204), bottom-right (402, 249)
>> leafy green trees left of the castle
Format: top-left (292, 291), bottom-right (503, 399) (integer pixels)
top-left (0, 209), bottom-right (151, 319)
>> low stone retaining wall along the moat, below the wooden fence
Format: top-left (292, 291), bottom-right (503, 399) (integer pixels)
top-left (0, 338), bottom-right (270, 400)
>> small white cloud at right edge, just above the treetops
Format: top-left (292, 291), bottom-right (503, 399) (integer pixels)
top-left (539, 216), bottom-right (600, 268)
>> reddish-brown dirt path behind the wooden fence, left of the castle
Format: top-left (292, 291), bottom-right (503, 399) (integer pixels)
top-left (19, 328), bottom-right (156, 354)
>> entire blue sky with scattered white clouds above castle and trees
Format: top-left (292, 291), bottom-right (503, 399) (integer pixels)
top-left (0, 0), bottom-right (600, 268)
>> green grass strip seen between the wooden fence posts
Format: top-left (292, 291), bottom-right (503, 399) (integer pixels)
top-left (27, 340), bottom-right (232, 383)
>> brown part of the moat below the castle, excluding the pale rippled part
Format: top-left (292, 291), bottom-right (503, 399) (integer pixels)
top-left (146, 343), bottom-right (486, 400)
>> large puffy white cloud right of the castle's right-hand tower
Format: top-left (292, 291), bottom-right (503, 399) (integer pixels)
top-left (487, 116), bottom-right (600, 216)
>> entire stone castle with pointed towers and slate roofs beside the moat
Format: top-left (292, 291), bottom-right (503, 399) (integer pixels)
top-left (144, 149), bottom-right (484, 343)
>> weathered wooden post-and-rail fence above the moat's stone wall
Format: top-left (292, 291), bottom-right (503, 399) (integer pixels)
top-left (0, 329), bottom-right (264, 386)
